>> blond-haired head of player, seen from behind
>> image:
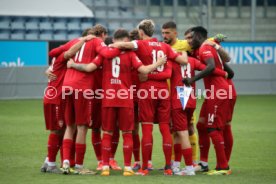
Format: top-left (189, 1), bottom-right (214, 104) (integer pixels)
top-left (137, 19), bottom-right (155, 39)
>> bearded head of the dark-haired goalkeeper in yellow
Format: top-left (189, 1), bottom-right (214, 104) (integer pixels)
top-left (162, 21), bottom-right (177, 45)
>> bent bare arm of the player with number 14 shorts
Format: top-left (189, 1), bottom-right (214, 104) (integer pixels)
top-left (183, 57), bottom-right (216, 86)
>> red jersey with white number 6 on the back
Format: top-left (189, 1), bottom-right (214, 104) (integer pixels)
top-left (93, 51), bottom-right (142, 108)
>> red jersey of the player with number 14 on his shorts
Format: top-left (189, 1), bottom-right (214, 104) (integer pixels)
top-left (198, 44), bottom-right (229, 92)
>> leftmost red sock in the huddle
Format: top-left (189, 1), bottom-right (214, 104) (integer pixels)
top-left (48, 133), bottom-right (60, 162)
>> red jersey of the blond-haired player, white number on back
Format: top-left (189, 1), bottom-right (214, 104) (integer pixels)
top-left (133, 38), bottom-right (178, 89)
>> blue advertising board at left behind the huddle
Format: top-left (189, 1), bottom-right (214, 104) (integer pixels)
top-left (0, 41), bottom-right (48, 67)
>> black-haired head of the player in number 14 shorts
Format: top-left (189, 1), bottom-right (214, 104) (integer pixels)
top-left (191, 26), bottom-right (208, 49)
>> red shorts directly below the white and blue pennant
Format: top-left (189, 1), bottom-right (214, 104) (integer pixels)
top-left (172, 108), bottom-right (195, 132)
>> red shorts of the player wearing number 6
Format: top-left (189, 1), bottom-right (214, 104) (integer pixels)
top-left (102, 107), bottom-right (134, 131)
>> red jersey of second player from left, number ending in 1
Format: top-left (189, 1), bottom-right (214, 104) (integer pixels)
top-left (63, 38), bottom-right (119, 90)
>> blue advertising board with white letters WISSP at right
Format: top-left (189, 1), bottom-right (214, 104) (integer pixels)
top-left (222, 42), bottom-right (276, 64)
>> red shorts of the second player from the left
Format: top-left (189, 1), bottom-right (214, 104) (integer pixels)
top-left (65, 92), bottom-right (92, 126)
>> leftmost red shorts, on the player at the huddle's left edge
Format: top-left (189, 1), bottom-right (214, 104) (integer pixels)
top-left (43, 103), bottom-right (65, 130)
